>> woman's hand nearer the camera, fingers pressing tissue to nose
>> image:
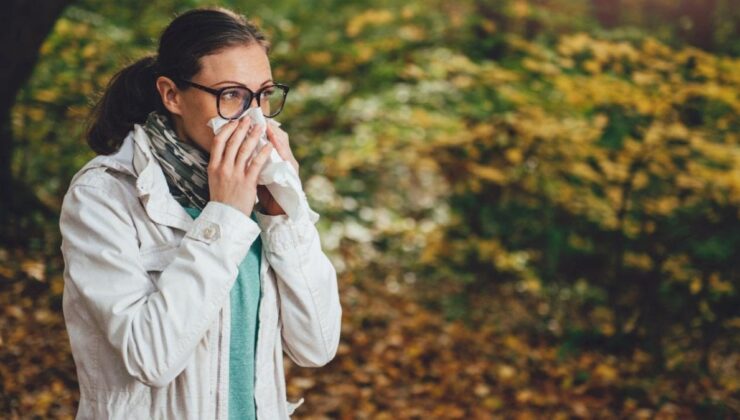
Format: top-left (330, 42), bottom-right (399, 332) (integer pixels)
top-left (208, 117), bottom-right (273, 216)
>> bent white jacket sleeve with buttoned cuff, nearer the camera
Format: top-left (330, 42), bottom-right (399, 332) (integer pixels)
top-left (59, 177), bottom-right (260, 387)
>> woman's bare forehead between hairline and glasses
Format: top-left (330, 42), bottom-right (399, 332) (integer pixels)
top-left (193, 43), bottom-right (272, 89)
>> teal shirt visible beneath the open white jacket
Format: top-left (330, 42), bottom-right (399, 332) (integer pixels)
top-left (185, 207), bottom-right (262, 420)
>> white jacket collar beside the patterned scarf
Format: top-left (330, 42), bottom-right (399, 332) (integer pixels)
top-left (72, 124), bottom-right (193, 231)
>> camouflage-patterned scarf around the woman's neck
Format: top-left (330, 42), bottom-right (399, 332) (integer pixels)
top-left (143, 111), bottom-right (210, 210)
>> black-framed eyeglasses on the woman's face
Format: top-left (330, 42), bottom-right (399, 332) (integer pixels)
top-left (177, 78), bottom-right (290, 120)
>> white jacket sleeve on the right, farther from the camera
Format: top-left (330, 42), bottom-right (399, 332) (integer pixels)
top-left (255, 208), bottom-right (342, 367)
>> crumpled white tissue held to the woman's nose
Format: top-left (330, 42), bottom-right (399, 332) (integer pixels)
top-left (208, 107), bottom-right (316, 220)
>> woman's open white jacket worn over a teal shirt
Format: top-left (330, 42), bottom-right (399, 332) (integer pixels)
top-left (59, 125), bottom-right (342, 420)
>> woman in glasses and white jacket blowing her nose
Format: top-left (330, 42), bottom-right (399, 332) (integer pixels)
top-left (60, 8), bottom-right (342, 420)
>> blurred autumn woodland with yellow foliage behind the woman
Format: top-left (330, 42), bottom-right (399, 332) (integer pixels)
top-left (0, 0), bottom-right (740, 419)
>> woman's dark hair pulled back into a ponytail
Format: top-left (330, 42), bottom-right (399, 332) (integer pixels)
top-left (86, 6), bottom-right (270, 155)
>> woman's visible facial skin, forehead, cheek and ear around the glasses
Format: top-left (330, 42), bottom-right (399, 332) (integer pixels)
top-left (157, 43), bottom-right (272, 153)
